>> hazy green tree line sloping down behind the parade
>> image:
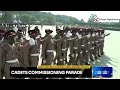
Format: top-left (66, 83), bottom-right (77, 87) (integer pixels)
top-left (0, 11), bottom-right (84, 25)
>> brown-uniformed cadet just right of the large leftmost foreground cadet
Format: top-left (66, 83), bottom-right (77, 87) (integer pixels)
top-left (15, 29), bottom-right (30, 68)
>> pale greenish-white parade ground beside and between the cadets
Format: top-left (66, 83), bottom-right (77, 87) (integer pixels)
top-left (32, 27), bottom-right (120, 79)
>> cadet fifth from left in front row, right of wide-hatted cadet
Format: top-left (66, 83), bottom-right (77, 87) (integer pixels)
top-left (54, 29), bottom-right (67, 65)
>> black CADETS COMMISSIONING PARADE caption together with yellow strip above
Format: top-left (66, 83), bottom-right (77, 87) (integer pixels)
top-left (10, 65), bottom-right (91, 78)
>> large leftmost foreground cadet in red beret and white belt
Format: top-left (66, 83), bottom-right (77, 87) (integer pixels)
top-left (0, 30), bottom-right (20, 79)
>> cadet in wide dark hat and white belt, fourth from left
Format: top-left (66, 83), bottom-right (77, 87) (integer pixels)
top-left (41, 29), bottom-right (54, 65)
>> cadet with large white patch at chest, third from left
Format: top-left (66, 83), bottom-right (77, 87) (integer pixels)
top-left (28, 30), bottom-right (40, 67)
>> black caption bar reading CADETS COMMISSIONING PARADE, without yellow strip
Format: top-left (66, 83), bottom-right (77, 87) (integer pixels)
top-left (10, 67), bottom-right (92, 78)
